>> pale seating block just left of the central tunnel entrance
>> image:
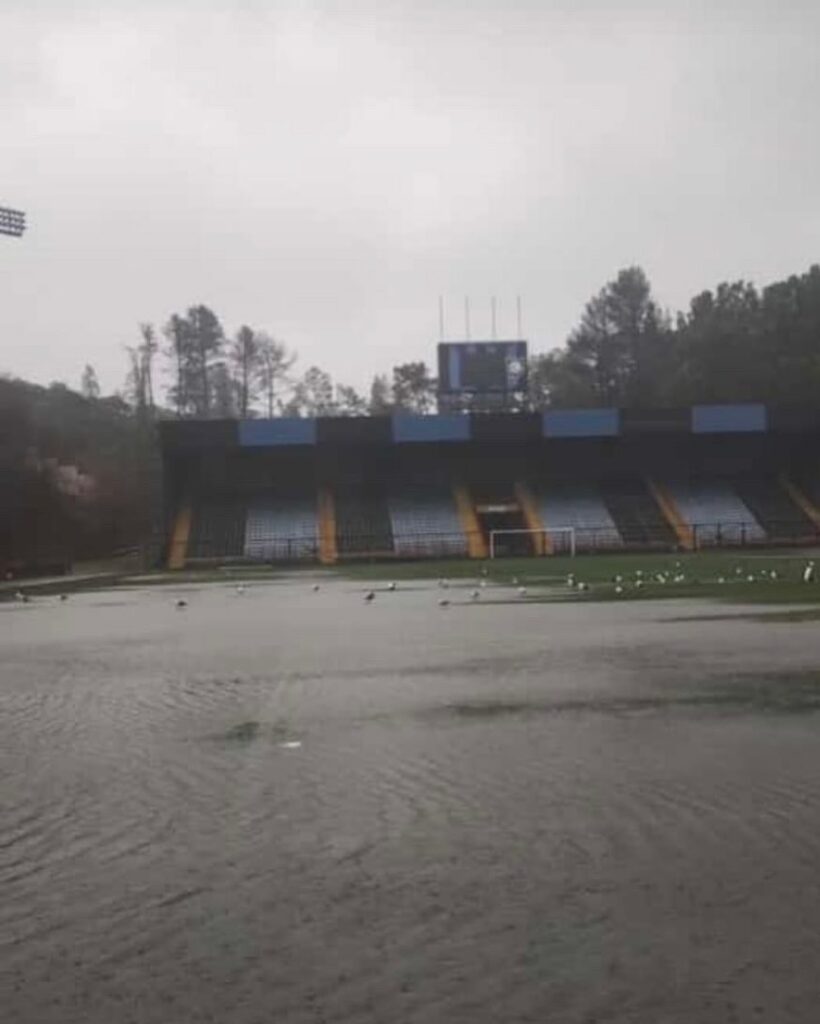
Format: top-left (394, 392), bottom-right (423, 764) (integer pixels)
top-left (387, 483), bottom-right (467, 557)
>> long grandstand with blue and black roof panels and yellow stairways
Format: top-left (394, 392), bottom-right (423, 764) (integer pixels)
top-left (162, 406), bottom-right (820, 567)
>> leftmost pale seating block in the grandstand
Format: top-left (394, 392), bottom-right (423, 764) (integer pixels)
top-left (245, 496), bottom-right (318, 561)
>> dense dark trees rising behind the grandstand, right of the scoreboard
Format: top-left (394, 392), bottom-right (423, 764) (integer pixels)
top-left (530, 265), bottom-right (820, 409)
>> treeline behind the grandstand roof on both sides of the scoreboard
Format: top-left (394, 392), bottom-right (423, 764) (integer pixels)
top-left (116, 266), bottom-right (820, 419)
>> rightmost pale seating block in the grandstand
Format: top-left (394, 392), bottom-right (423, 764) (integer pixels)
top-left (664, 477), bottom-right (766, 547)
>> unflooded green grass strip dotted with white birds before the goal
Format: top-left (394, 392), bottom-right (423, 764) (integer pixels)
top-left (332, 550), bottom-right (820, 604)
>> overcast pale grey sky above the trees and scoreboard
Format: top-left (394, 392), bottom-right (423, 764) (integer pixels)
top-left (0, 0), bottom-right (820, 390)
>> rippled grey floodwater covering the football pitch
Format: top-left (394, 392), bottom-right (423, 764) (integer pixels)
top-left (0, 580), bottom-right (820, 1024)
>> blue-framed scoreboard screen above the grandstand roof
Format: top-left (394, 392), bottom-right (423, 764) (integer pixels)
top-left (438, 341), bottom-right (527, 394)
